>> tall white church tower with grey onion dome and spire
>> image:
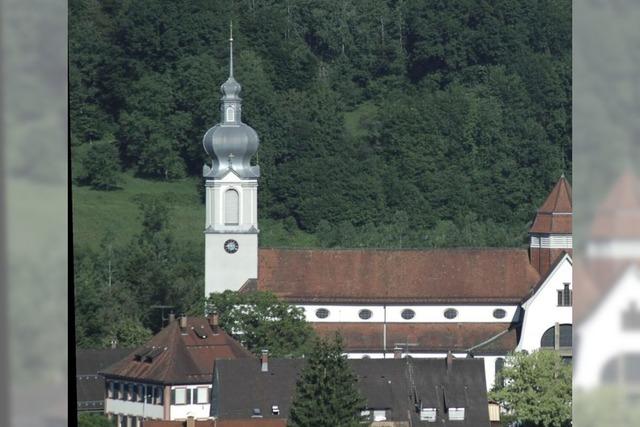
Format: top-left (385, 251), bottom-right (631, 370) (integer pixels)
top-left (202, 25), bottom-right (260, 296)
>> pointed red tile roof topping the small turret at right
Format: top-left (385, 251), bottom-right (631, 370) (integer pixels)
top-left (529, 175), bottom-right (573, 234)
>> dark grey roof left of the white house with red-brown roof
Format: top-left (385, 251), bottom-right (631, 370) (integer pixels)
top-left (76, 348), bottom-right (131, 411)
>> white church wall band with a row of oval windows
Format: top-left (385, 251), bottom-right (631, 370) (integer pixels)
top-left (298, 304), bottom-right (518, 323)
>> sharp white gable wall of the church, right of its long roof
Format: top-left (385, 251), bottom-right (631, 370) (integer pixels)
top-left (516, 256), bottom-right (573, 352)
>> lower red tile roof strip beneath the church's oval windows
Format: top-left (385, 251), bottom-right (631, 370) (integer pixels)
top-left (313, 322), bottom-right (518, 355)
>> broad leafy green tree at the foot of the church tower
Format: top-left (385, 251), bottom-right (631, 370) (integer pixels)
top-left (207, 291), bottom-right (313, 357)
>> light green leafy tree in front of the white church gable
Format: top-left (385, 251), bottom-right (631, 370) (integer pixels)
top-left (490, 350), bottom-right (571, 427)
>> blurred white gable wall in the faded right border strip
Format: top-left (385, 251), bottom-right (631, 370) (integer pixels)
top-left (574, 267), bottom-right (640, 389)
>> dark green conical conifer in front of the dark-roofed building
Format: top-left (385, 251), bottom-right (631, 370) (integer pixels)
top-left (288, 336), bottom-right (365, 427)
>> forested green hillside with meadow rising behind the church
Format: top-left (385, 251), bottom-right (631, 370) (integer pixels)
top-left (69, 0), bottom-right (572, 346)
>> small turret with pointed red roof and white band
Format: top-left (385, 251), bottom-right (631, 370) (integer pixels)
top-left (529, 174), bottom-right (573, 275)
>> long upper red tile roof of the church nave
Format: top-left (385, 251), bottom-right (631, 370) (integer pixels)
top-left (255, 248), bottom-right (540, 303)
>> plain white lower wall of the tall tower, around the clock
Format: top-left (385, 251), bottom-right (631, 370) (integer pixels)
top-left (204, 233), bottom-right (258, 296)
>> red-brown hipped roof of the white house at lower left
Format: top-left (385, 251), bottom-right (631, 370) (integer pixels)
top-left (103, 317), bottom-right (252, 384)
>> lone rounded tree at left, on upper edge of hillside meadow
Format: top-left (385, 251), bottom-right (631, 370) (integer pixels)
top-left (80, 140), bottom-right (122, 190)
